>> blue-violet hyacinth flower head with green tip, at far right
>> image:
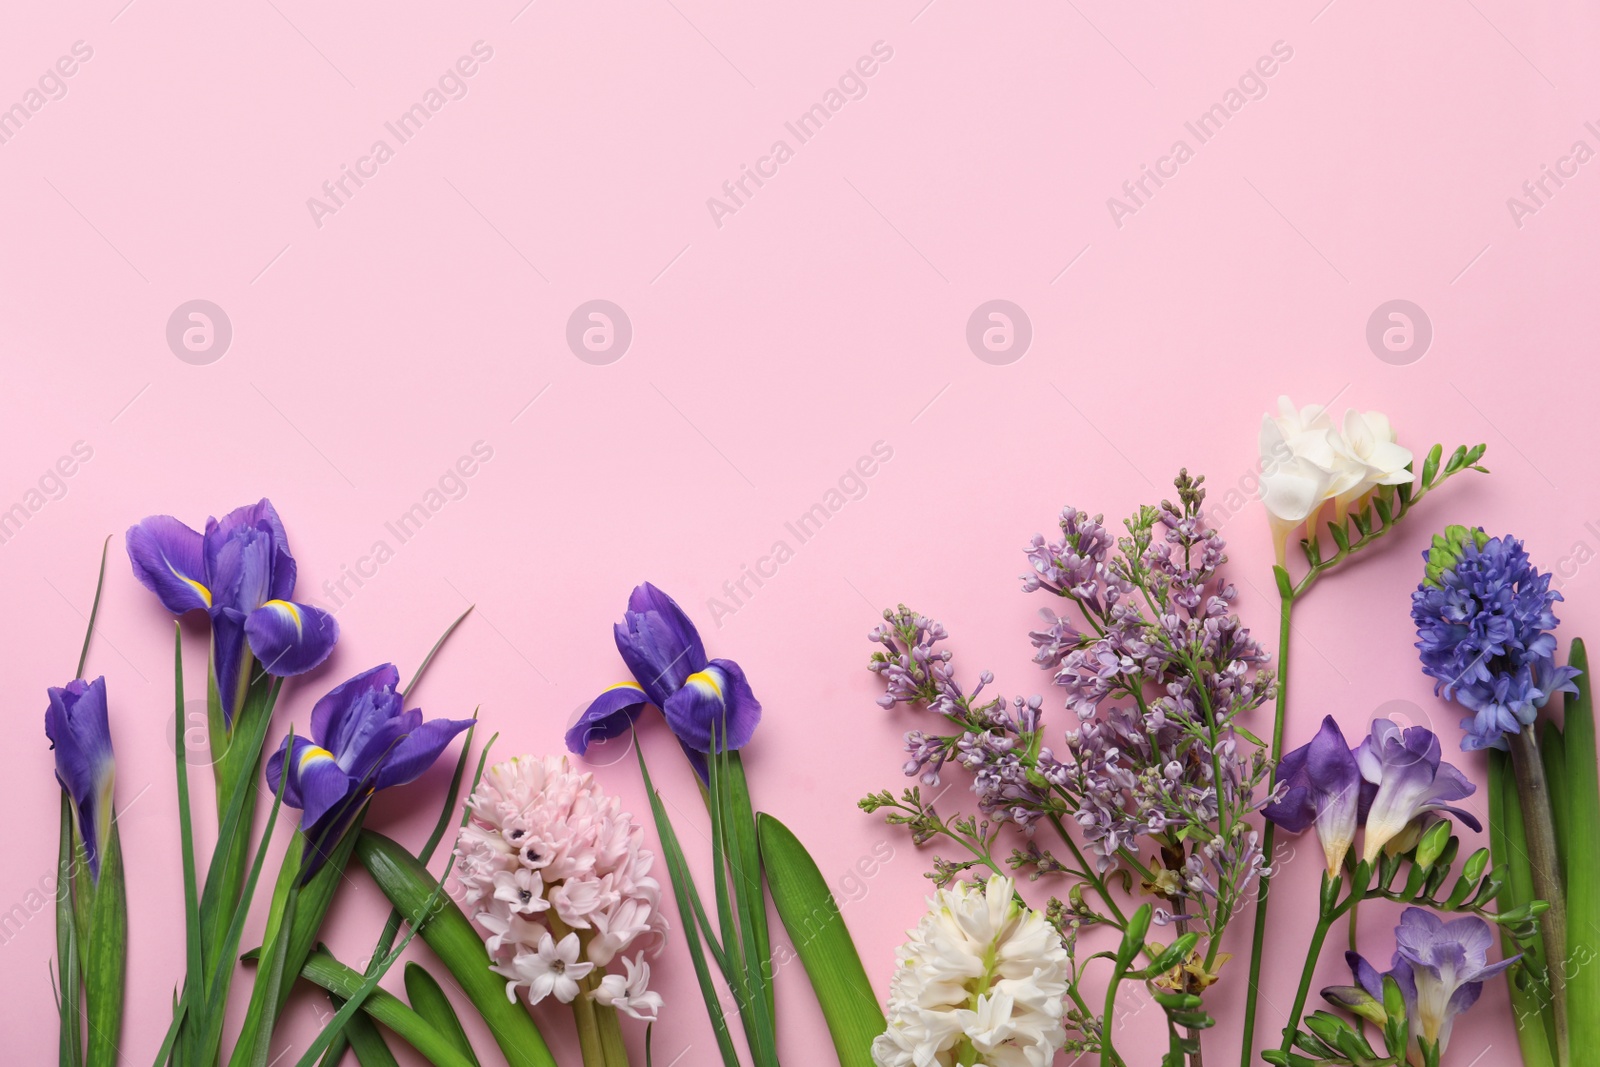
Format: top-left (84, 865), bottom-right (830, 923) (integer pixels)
top-left (1411, 526), bottom-right (1578, 750)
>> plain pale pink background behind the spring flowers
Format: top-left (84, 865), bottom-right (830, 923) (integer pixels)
top-left (0, 0), bottom-right (1600, 1067)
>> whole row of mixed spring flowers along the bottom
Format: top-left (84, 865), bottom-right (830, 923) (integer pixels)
top-left (42, 398), bottom-right (1600, 1067)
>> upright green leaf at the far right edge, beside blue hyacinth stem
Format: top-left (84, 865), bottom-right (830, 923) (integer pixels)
top-left (1563, 640), bottom-right (1600, 1059)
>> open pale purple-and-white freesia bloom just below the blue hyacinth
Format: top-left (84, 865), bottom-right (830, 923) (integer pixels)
top-left (1355, 718), bottom-right (1483, 862)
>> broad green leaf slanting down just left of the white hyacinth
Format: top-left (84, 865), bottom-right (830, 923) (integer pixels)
top-left (757, 813), bottom-right (886, 1067)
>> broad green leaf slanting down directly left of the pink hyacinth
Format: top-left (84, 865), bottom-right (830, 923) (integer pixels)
top-left (355, 830), bottom-right (555, 1067)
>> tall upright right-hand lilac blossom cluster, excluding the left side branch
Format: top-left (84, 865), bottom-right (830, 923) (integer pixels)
top-left (1022, 472), bottom-right (1274, 907)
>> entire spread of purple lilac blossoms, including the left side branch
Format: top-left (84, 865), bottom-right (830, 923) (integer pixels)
top-left (870, 472), bottom-right (1274, 953)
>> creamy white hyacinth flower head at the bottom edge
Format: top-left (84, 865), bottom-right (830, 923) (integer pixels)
top-left (872, 875), bottom-right (1067, 1067)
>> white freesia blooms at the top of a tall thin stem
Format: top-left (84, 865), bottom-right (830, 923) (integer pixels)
top-left (1259, 397), bottom-right (1411, 566)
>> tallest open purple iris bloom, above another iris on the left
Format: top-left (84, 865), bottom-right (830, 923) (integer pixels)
top-left (128, 499), bottom-right (339, 723)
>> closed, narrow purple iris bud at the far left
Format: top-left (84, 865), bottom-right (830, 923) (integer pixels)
top-left (45, 677), bottom-right (117, 883)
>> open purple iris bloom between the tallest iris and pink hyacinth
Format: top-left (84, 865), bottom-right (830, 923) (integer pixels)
top-left (267, 664), bottom-right (472, 880)
